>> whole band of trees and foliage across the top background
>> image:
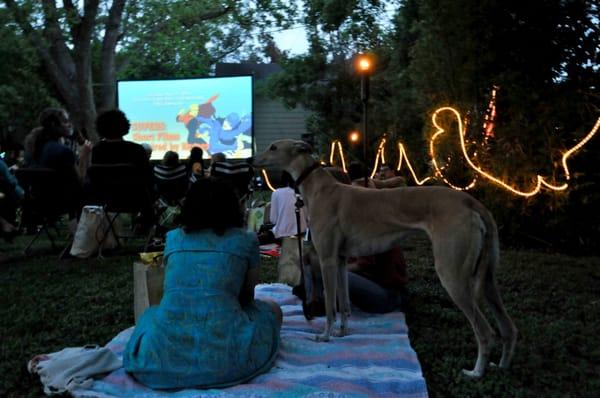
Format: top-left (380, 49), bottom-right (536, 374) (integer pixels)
top-left (0, 0), bottom-right (600, 250)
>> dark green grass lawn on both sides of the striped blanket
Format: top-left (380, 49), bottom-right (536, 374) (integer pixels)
top-left (0, 232), bottom-right (600, 397)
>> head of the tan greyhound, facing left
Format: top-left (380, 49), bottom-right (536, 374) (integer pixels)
top-left (251, 140), bottom-right (314, 172)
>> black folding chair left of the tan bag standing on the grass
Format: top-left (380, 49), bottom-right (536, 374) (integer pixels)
top-left (16, 168), bottom-right (73, 254)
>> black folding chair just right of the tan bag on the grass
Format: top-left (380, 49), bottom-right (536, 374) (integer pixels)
top-left (87, 164), bottom-right (156, 257)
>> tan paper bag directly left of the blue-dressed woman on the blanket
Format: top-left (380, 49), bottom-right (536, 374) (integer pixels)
top-left (133, 261), bottom-right (165, 323)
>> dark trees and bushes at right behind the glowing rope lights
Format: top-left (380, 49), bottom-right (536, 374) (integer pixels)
top-left (270, 0), bottom-right (600, 247)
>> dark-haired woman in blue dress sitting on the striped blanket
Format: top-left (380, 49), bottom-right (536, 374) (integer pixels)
top-left (123, 178), bottom-right (282, 388)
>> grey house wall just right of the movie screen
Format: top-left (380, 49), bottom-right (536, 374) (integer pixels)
top-left (254, 97), bottom-right (308, 154)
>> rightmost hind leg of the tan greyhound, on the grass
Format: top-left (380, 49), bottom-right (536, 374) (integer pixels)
top-left (484, 268), bottom-right (518, 369)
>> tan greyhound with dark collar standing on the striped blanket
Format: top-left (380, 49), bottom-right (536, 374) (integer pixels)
top-left (252, 140), bottom-right (517, 378)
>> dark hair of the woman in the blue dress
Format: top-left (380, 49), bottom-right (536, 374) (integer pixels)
top-left (180, 178), bottom-right (244, 235)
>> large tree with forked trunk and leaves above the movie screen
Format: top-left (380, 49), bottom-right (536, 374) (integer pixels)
top-left (4, 0), bottom-right (298, 138)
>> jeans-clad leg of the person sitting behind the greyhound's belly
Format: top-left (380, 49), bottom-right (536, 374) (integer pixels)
top-left (348, 272), bottom-right (401, 314)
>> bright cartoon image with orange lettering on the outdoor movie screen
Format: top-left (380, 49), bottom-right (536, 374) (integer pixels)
top-left (117, 76), bottom-right (253, 159)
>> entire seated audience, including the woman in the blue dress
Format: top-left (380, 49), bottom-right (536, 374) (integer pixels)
top-left (0, 108), bottom-right (408, 389)
